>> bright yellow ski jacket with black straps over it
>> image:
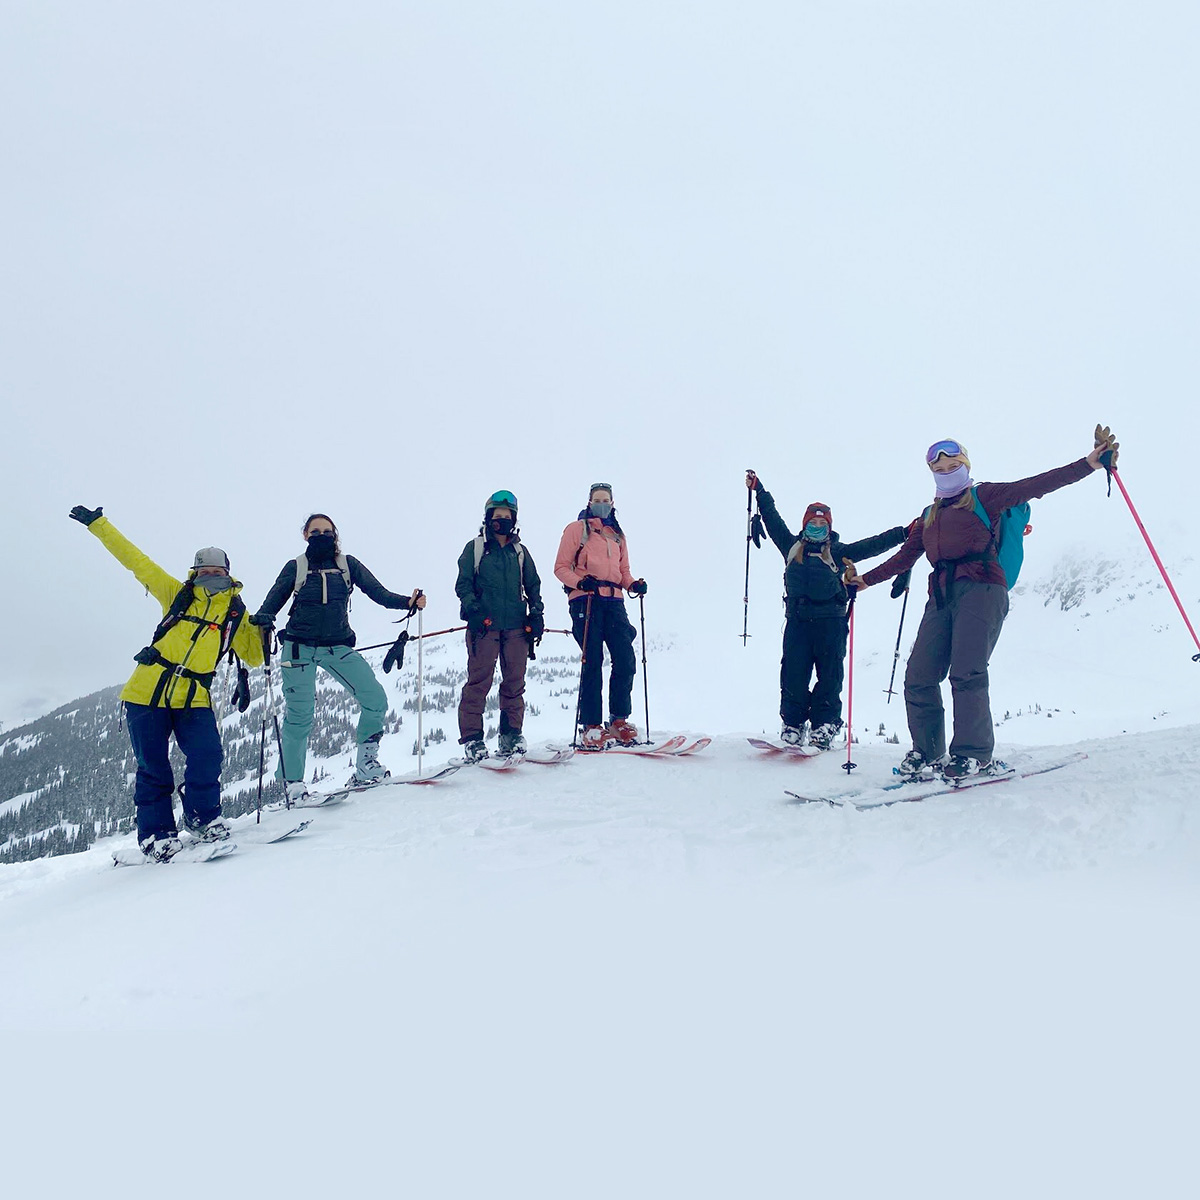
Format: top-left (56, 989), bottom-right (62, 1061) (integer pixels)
top-left (88, 517), bottom-right (263, 708)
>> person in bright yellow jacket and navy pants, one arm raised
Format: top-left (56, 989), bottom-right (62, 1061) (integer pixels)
top-left (71, 504), bottom-right (263, 862)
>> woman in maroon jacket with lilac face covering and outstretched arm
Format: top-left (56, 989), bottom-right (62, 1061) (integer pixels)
top-left (846, 425), bottom-right (1118, 781)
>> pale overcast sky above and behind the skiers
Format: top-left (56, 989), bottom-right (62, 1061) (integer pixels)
top-left (0, 0), bottom-right (1200, 726)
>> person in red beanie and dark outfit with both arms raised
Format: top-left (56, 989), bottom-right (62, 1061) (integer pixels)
top-left (746, 470), bottom-right (906, 750)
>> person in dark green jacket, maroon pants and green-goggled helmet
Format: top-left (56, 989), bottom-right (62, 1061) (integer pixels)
top-left (455, 491), bottom-right (546, 762)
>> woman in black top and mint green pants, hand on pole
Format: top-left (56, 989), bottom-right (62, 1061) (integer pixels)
top-left (250, 512), bottom-right (425, 806)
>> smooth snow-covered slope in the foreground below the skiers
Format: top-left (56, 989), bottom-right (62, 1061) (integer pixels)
top-left (0, 727), bottom-right (1200, 1196)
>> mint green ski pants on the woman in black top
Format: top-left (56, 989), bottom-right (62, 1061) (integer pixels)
top-left (275, 638), bottom-right (388, 784)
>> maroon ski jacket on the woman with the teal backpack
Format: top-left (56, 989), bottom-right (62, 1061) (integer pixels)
top-left (863, 458), bottom-right (1092, 594)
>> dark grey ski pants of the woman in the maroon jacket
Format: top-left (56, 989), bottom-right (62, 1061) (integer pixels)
top-left (904, 580), bottom-right (1008, 762)
